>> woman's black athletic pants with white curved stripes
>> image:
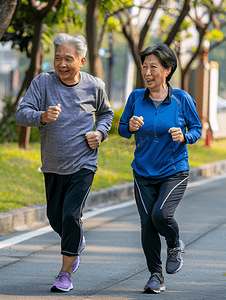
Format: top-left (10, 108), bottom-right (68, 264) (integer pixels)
top-left (134, 171), bottom-right (189, 274)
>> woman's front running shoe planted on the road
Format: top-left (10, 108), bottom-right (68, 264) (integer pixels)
top-left (144, 273), bottom-right (166, 294)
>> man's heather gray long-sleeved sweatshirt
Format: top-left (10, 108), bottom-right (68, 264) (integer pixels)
top-left (16, 71), bottom-right (114, 175)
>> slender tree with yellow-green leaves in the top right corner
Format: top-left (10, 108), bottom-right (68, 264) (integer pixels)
top-left (163, 0), bottom-right (226, 91)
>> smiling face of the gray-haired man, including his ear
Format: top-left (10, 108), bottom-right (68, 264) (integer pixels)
top-left (54, 45), bottom-right (86, 85)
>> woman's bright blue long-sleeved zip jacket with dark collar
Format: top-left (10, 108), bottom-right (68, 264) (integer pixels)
top-left (119, 85), bottom-right (202, 178)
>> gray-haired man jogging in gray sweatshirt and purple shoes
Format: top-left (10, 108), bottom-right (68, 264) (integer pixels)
top-left (16, 33), bottom-right (114, 292)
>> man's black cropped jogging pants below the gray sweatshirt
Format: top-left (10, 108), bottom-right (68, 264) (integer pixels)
top-left (44, 169), bottom-right (94, 256)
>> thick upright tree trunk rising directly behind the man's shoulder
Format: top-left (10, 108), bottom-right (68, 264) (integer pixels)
top-left (86, 0), bottom-right (104, 80)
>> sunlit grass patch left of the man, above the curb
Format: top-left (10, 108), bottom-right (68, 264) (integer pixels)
top-left (0, 143), bottom-right (45, 212)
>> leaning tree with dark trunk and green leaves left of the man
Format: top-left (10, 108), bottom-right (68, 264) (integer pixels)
top-left (0, 0), bottom-right (84, 148)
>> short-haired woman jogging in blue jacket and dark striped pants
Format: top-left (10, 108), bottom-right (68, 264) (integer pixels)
top-left (119, 43), bottom-right (201, 293)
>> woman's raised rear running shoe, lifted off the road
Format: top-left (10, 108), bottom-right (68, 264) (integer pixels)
top-left (166, 240), bottom-right (185, 274)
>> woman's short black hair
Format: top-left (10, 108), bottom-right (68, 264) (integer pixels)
top-left (140, 43), bottom-right (177, 81)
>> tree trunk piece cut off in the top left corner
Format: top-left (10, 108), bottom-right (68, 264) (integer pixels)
top-left (0, 0), bottom-right (17, 40)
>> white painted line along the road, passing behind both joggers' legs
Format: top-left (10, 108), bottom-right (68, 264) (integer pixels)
top-left (0, 174), bottom-right (226, 249)
